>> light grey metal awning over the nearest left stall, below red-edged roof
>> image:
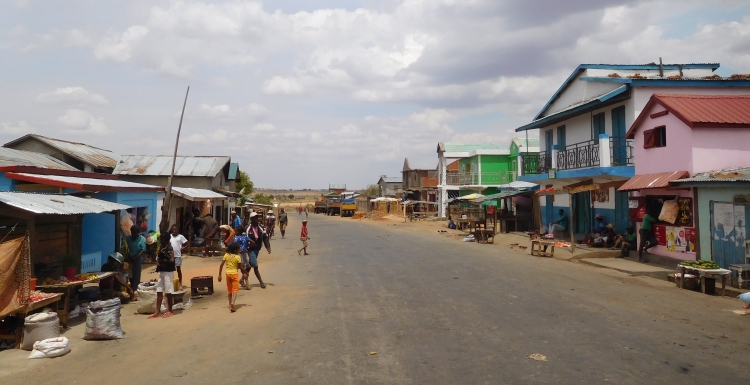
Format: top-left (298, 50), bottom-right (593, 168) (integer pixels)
top-left (0, 191), bottom-right (131, 215)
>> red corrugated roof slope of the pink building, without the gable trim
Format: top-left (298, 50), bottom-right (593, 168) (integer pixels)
top-left (653, 94), bottom-right (750, 127)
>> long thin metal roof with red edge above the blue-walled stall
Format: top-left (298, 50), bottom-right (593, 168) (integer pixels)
top-left (5, 172), bottom-right (164, 191)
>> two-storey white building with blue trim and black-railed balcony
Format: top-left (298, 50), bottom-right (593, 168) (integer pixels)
top-left (516, 63), bottom-right (750, 236)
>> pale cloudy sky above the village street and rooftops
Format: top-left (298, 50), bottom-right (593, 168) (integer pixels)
top-left (0, 0), bottom-right (750, 189)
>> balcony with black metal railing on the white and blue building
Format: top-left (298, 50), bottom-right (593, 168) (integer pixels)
top-left (521, 135), bottom-right (633, 179)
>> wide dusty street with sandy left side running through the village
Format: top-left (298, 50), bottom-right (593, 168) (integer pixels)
top-left (0, 215), bottom-right (750, 385)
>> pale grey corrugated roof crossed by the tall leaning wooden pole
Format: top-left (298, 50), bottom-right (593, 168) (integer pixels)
top-left (112, 155), bottom-right (230, 177)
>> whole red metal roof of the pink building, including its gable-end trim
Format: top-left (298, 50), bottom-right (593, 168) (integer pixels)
top-left (626, 94), bottom-right (750, 139)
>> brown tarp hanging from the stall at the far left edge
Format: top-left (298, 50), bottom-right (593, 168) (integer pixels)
top-left (0, 236), bottom-right (31, 318)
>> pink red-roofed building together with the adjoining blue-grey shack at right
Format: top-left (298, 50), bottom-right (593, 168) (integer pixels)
top-left (619, 94), bottom-right (750, 268)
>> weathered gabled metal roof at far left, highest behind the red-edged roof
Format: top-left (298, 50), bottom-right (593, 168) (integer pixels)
top-left (3, 134), bottom-right (118, 174)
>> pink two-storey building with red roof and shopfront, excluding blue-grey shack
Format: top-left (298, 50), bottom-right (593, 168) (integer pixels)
top-left (619, 94), bottom-right (750, 260)
